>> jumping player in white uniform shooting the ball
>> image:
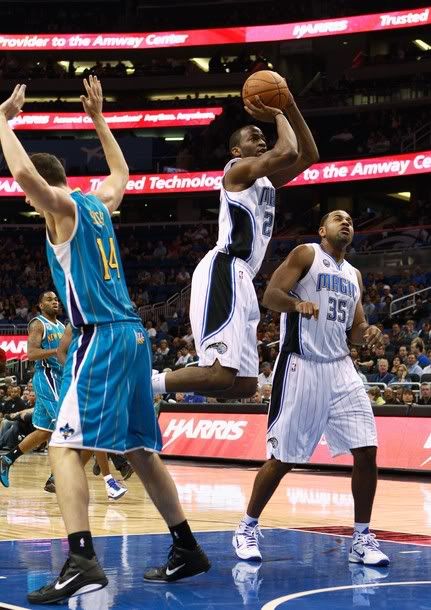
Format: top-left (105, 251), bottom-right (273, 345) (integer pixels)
top-left (153, 89), bottom-right (318, 398)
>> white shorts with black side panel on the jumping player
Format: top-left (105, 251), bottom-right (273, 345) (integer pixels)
top-left (190, 250), bottom-right (260, 377)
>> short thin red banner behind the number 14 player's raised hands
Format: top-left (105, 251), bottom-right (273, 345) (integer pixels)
top-left (9, 106), bottom-right (223, 131)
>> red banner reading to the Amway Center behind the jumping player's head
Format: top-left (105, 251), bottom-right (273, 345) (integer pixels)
top-left (0, 150), bottom-right (431, 197)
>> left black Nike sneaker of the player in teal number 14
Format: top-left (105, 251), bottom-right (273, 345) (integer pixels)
top-left (27, 553), bottom-right (108, 604)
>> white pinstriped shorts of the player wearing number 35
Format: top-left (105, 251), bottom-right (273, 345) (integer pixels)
top-left (266, 352), bottom-right (377, 464)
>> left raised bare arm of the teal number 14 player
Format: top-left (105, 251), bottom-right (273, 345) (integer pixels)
top-left (0, 85), bottom-right (75, 217)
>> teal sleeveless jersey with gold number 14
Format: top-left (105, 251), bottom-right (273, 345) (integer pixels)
top-left (46, 190), bottom-right (139, 327)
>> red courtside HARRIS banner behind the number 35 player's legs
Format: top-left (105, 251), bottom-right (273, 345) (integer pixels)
top-left (159, 412), bottom-right (431, 471)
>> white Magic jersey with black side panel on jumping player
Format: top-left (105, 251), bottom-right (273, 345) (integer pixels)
top-left (216, 158), bottom-right (275, 275)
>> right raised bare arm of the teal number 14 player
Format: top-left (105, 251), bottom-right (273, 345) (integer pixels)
top-left (81, 75), bottom-right (129, 214)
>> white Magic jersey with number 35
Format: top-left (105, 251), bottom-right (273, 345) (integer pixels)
top-left (280, 244), bottom-right (361, 362)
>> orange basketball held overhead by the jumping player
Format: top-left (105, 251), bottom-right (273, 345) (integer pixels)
top-left (242, 70), bottom-right (290, 110)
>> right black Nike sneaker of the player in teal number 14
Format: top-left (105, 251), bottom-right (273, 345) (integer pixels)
top-left (144, 544), bottom-right (211, 582)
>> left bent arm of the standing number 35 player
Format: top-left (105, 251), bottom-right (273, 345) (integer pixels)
top-left (262, 244), bottom-right (319, 320)
